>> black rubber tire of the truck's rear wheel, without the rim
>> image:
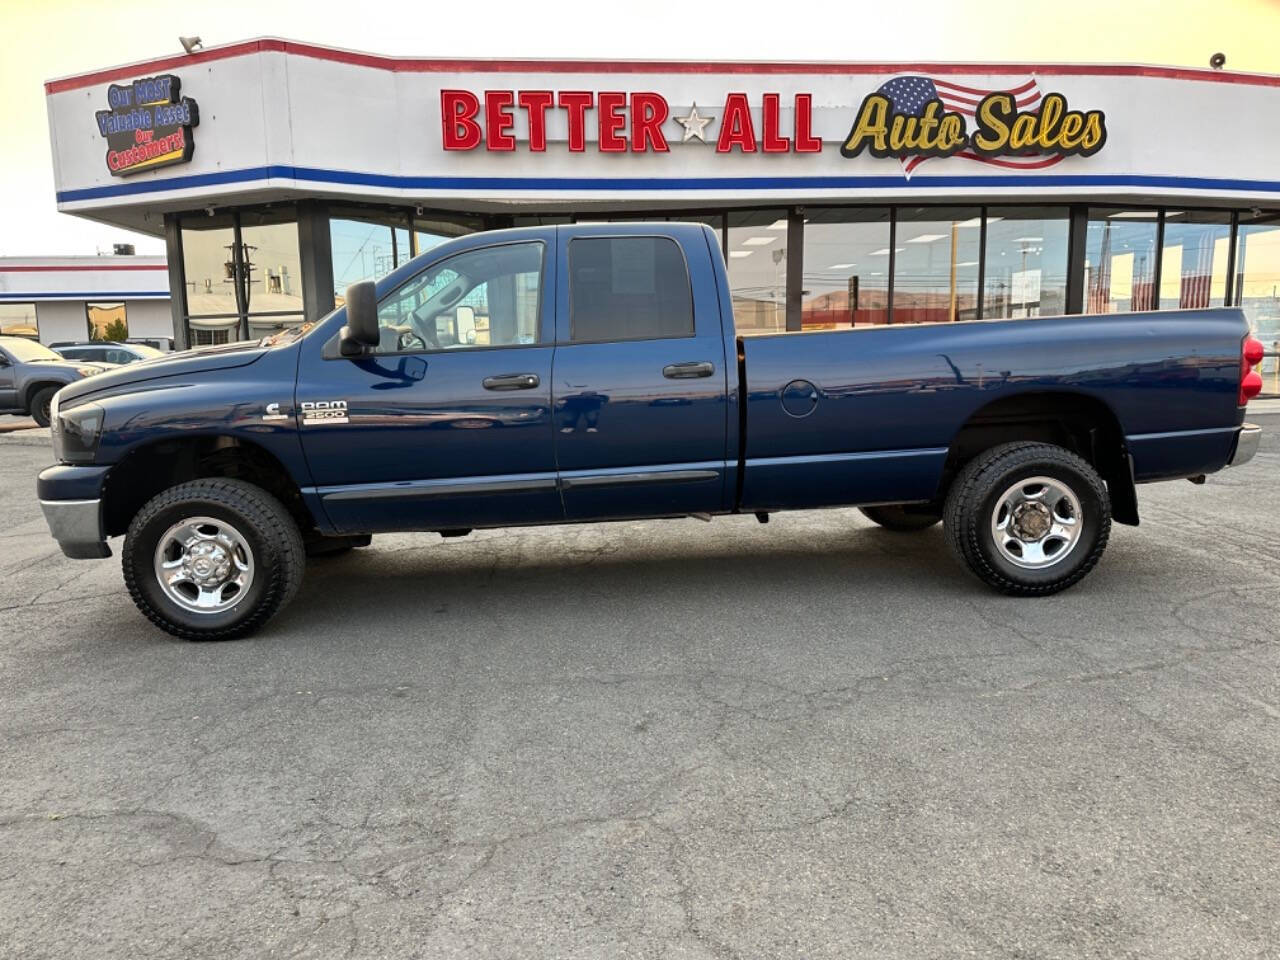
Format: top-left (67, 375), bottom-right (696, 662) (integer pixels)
top-left (943, 443), bottom-right (1111, 596)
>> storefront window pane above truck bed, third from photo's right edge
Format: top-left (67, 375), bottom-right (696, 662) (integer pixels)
top-left (1084, 210), bottom-right (1157, 314)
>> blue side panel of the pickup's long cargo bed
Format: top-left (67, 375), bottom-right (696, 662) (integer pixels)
top-left (739, 308), bottom-right (1247, 509)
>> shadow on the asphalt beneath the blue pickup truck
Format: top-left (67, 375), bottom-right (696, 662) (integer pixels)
top-left (266, 518), bottom-right (1114, 650)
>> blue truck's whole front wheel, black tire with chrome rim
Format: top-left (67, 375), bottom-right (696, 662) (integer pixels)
top-left (122, 477), bottom-right (306, 640)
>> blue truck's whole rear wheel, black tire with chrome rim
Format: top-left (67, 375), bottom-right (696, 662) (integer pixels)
top-left (945, 443), bottom-right (1111, 596)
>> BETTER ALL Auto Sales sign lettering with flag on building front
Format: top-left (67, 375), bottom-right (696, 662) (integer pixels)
top-left (440, 74), bottom-right (1107, 177)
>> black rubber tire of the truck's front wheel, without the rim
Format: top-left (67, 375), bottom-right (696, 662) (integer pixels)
top-left (120, 477), bottom-right (306, 640)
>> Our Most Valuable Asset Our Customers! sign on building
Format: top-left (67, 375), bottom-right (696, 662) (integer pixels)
top-left (95, 73), bottom-right (200, 177)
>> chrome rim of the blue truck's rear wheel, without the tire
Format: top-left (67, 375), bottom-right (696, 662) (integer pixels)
top-left (991, 476), bottom-right (1084, 570)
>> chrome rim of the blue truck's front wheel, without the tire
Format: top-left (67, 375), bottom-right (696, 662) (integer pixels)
top-left (155, 517), bottom-right (253, 613)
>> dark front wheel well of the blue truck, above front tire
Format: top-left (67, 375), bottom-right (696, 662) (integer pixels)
top-left (102, 434), bottom-right (316, 536)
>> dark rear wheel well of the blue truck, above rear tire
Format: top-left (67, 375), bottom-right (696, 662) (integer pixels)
top-left (940, 390), bottom-right (1138, 526)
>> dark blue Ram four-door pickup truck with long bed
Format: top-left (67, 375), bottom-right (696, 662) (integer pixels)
top-left (38, 223), bottom-right (1261, 639)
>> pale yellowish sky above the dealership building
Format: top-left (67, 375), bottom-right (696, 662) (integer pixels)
top-left (0, 0), bottom-right (1280, 256)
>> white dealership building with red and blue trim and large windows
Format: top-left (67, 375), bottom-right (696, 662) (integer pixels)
top-left (37, 40), bottom-right (1280, 371)
